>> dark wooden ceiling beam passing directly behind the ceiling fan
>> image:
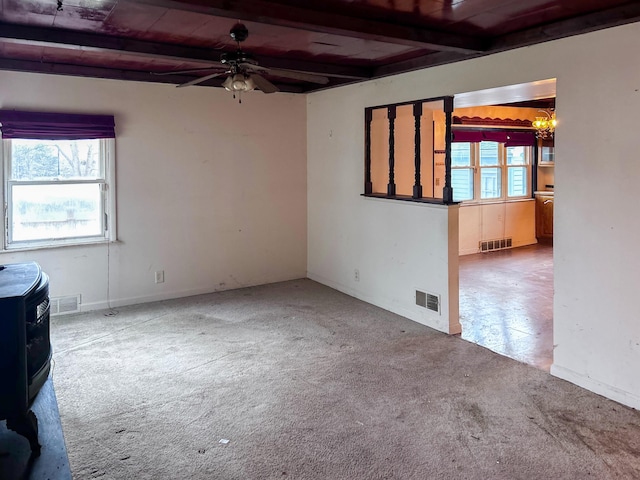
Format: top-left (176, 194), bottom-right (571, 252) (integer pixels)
top-left (0, 23), bottom-right (371, 80)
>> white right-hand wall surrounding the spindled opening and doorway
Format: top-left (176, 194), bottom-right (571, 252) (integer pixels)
top-left (307, 20), bottom-right (640, 408)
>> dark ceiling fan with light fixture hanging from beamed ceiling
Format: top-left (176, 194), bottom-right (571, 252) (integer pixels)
top-left (155, 23), bottom-right (329, 103)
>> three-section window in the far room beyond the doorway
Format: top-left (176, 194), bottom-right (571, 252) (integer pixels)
top-left (451, 141), bottom-right (531, 202)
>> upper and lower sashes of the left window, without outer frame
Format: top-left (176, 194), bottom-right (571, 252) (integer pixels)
top-left (8, 139), bottom-right (105, 242)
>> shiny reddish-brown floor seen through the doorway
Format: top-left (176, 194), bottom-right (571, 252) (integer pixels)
top-left (460, 244), bottom-right (553, 371)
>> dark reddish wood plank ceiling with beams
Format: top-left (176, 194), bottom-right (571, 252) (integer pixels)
top-left (0, 0), bottom-right (640, 92)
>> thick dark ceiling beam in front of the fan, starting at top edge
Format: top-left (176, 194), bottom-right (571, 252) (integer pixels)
top-left (120, 0), bottom-right (486, 53)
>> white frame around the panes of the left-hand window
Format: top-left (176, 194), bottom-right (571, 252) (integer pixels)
top-left (0, 138), bottom-right (117, 252)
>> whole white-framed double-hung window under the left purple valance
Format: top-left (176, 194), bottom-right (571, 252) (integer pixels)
top-left (0, 111), bottom-right (116, 250)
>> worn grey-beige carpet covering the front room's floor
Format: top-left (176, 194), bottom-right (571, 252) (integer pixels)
top-left (52, 280), bottom-right (640, 480)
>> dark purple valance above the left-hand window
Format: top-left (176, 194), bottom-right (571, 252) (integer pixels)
top-left (0, 110), bottom-right (116, 140)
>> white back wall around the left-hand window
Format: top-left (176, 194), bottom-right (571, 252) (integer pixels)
top-left (0, 72), bottom-right (306, 310)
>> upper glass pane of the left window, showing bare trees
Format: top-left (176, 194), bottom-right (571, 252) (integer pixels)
top-left (11, 139), bottom-right (104, 180)
